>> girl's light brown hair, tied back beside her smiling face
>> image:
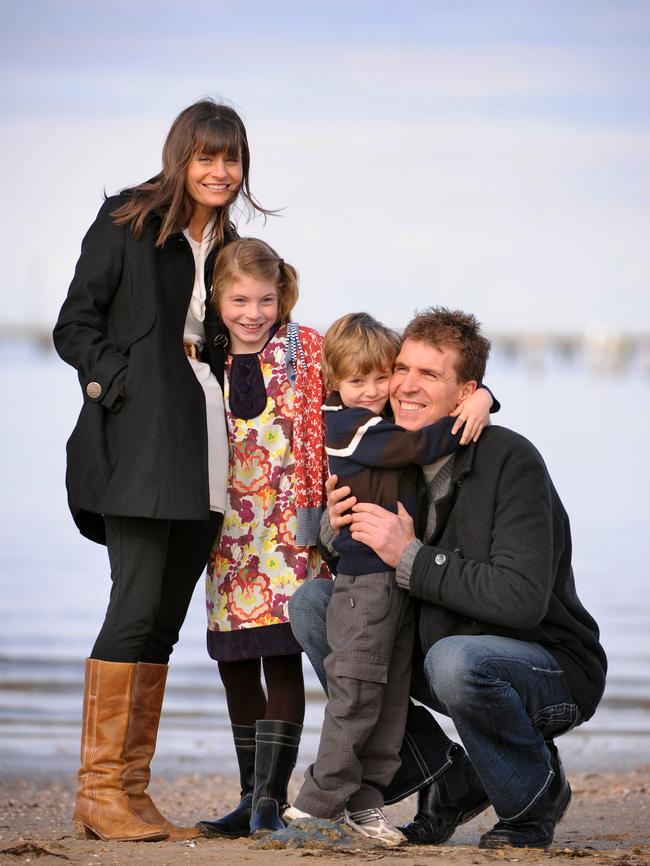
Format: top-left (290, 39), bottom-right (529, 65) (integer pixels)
top-left (210, 238), bottom-right (298, 325)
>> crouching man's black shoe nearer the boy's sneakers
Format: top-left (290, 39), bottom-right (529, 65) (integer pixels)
top-left (399, 743), bottom-right (490, 845)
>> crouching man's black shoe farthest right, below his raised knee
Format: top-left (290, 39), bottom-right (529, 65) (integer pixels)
top-left (479, 741), bottom-right (571, 848)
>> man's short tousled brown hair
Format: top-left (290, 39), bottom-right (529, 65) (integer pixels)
top-left (402, 307), bottom-right (490, 385)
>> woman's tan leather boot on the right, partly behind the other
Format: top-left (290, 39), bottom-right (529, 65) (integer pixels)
top-left (123, 662), bottom-right (201, 839)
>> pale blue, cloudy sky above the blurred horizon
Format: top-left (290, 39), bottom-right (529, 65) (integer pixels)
top-left (0, 0), bottom-right (650, 332)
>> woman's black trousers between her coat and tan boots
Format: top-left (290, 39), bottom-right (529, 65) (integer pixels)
top-left (91, 512), bottom-right (222, 664)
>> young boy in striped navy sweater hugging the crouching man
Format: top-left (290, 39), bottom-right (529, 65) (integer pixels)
top-left (287, 313), bottom-right (488, 846)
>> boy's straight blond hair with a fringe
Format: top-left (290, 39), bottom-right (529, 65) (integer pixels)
top-left (322, 313), bottom-right (402, 390)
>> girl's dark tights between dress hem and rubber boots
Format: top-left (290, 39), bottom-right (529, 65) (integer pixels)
top-left (219, 653), bottom-right (305, 725)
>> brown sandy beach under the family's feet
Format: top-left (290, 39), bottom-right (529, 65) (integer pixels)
top-left (0, 765), bottom-right (650, 866)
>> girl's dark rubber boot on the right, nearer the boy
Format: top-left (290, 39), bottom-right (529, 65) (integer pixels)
top-left (250, 719), bottom-right (302, 836)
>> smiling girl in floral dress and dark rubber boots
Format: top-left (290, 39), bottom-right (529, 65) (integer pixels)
top-left (197, 238), bottom-right (329, 836)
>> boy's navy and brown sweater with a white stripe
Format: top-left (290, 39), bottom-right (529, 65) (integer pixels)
top-left (323, 391), bottom-right (461, 574)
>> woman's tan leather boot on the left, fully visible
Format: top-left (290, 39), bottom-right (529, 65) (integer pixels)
top-left (74, 659), bottom-right (169, 842)
